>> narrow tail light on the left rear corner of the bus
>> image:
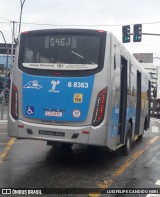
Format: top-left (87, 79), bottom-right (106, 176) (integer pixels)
top-left (11, 84), bottom-right (18, 120)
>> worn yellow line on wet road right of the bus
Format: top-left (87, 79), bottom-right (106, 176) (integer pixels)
top-left (88, 136), bottom-right (160, 197)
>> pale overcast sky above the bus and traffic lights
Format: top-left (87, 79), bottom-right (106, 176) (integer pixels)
top-left (0, 0), bottom-right (160, 63)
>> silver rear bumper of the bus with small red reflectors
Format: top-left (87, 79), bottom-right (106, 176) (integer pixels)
top-left (8, 118), bottom-right (106, 146)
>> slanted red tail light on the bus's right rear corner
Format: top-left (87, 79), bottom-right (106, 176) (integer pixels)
top-left (92, 88), bottom-right (107, 126)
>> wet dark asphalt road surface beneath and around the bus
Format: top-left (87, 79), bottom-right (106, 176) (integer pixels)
top-left (0, 119), bottom-right (160, 197)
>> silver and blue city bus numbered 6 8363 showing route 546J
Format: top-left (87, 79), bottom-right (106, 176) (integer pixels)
top-left (8, 29), bottom-right (150, 153)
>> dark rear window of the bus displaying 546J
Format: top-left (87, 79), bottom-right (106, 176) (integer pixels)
top-left (22, 34), bottom-right (101, 71)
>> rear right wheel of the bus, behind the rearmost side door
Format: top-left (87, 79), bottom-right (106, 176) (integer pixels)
top-left (123, 123), bottom-right (132, 155)
